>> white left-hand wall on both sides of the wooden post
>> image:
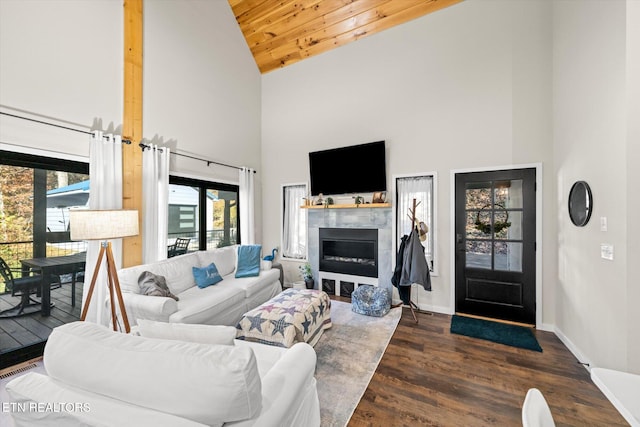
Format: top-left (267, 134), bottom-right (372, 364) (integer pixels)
top-left (0, 0), bottom-right (262, 241)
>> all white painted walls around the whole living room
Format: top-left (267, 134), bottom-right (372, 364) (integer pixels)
top-left (0, 0), bottom-right (640, 426)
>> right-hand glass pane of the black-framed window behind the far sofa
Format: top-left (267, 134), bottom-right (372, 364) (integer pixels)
top-left (206, 189), bottom-right (238, 249)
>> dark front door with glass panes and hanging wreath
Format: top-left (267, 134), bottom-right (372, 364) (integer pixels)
top-left (455, 169), bottom-right (536, 324)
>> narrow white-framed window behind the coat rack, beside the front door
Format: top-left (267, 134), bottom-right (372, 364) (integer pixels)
top-left (395, 173), bottom-right (437, 275)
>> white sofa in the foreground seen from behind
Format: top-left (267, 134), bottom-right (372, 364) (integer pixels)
top-left (6, 322), bottom-right (320, 427)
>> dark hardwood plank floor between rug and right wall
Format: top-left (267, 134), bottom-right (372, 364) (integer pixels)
top-left (342, 306), bottom-right (628, 427)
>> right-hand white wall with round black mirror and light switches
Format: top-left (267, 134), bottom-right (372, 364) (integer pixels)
top-left (553, 1), bottom-right (637, 370)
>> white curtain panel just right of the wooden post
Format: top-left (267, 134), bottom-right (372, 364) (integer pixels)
top-left (142, 144), bottom-right (170, 264)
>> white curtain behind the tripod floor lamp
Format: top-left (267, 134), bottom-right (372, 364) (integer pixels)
top-left (82, 131), bottom-right (122, 325)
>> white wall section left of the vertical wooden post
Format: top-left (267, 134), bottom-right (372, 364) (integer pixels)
top-left (0, 0), bottom-right (123, 157)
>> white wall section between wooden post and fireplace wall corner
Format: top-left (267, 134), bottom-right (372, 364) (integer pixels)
top-left (143, 0), bottom-right (263, 242)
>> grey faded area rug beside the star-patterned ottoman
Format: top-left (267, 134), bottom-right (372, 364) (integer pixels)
top-left (314, 301), bottom-right (402, 427)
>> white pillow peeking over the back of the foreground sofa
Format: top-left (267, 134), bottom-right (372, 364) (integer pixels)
top-left (137, 319), bottom-right (236, 345)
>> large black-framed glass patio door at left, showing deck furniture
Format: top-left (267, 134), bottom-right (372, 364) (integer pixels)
top-left (0, 151), bottom-right (90, 369)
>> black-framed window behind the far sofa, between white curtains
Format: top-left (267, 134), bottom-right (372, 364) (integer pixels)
top-left (168, 176), bottom-right (240, 251)
